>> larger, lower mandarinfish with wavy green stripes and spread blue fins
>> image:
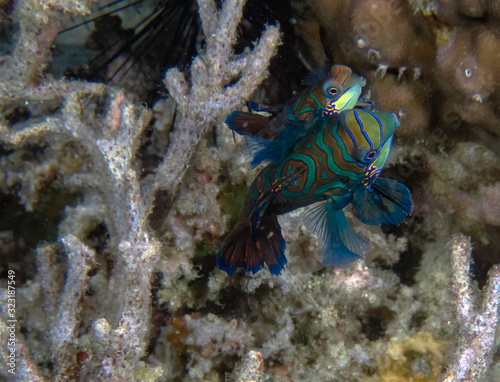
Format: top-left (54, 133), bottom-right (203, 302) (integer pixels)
top-left (217, 109), bottom-right (412, 275)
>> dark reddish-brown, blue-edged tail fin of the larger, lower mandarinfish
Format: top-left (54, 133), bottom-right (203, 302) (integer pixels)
top-left (217, 215), bottom-right (287, 275)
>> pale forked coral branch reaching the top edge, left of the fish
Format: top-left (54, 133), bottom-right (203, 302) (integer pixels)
top-left (155, 0), bottom-right (279, 210)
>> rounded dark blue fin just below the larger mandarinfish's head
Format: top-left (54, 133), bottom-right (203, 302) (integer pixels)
top-left (352, 178), bottom-right (413, 225)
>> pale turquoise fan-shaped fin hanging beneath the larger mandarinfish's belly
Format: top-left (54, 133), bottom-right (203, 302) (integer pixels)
top-left (305, 201), bottom-right (370, 267)
